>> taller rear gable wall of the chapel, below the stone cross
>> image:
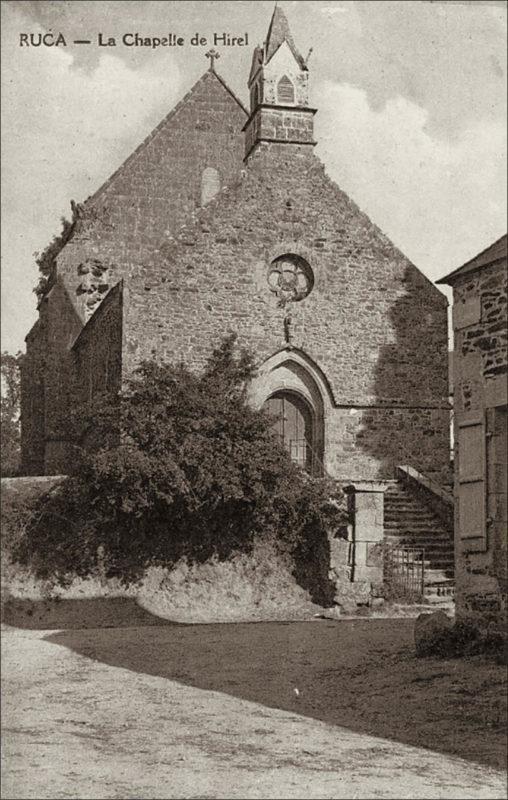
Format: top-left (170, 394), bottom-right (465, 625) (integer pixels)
top-left (87, 71), bottom-right (247, 265)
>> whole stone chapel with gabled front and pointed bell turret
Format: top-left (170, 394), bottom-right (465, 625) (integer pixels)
top-left (22, 7), bottom-right (449, 600)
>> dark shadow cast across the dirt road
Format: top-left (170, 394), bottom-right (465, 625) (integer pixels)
top-left (5, 598), bottom-right (500, 769)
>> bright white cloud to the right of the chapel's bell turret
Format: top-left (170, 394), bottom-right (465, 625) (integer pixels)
top-left (317, 81), bottom-right (506, 280)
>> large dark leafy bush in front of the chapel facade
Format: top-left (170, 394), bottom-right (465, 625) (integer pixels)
top-left (15, 336), bottom-right (344, 597)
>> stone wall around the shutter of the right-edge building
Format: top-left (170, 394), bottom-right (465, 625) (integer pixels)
top-left (453, 259), bottom-right (508, 625)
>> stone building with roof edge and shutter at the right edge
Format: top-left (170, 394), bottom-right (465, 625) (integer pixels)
top-left (439, 236), bottom-right (508, 623)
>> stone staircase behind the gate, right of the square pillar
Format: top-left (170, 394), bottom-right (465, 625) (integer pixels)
top-left (384, 481), bottom-right (455, 605)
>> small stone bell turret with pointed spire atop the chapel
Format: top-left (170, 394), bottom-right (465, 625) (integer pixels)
top-left (244, 6), bottom-right (316, 158)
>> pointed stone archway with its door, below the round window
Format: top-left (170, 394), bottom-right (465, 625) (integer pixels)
top-left (249, 350), bottom-right (332, 475)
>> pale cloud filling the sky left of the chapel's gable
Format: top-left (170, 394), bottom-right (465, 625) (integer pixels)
top-left (2, 4), bottom-right (179, 349)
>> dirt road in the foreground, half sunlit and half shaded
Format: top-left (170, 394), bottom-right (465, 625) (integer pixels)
top-left (2, 620), bottom-right (506, 800)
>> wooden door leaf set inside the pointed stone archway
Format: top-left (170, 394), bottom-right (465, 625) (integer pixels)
top-left (264, 391), bottom-right (314, 473)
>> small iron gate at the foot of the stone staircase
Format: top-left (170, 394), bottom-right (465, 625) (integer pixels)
top-left (384, 546), bottom-right (425, 603)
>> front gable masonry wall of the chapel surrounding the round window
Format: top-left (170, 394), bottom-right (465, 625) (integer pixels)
top-left (124, 144), bottom-right (448, 480)
